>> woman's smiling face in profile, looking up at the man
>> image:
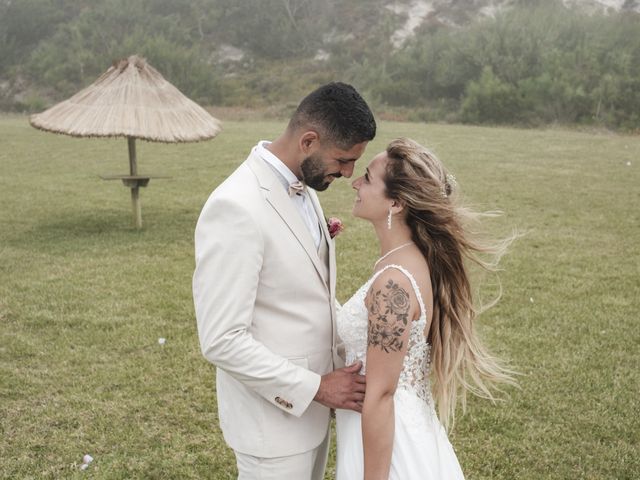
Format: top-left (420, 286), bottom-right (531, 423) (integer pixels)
top-left (351, 152), bottom-right (393, 223)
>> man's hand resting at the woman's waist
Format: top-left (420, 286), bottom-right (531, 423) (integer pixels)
top-left (314, 362), bottom-right (365, 412)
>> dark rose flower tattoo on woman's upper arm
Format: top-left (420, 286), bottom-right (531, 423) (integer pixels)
top-left (365, 280), bottom-right (410, 353)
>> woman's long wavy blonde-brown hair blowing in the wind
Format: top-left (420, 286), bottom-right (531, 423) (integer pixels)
top-left (385, 138), bottom-right (515, 428)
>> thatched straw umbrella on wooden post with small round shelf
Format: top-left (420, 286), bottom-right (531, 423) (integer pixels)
top-left (29, 55), bottom-right (221, 228)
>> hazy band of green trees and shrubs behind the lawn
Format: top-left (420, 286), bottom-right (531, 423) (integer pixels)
top-left (0, 0), bottom-right (640, 130)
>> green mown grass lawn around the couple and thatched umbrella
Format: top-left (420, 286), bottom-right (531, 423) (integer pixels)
top-left (0, 116), bottom-right (640, 480)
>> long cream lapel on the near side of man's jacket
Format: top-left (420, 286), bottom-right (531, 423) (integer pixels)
top-left (249, 152), bottom-right (326, 283)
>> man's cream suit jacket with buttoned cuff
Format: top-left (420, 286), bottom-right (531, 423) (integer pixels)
top-left (193, 152), bottom-right (340, 457)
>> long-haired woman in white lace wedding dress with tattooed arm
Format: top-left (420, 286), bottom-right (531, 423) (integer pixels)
top-left (336, 139), bottom-right (513, 480)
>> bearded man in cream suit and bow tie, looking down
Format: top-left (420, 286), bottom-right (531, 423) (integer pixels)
top-left (193, 83), bottom-right (376, 480)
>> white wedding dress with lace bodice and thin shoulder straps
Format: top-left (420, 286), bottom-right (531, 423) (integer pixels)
top-left (336, 265), bottom-right (464, 480)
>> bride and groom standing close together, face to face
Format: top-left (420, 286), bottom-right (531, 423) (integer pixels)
top-left (193, 83), bottom-right (510, 480)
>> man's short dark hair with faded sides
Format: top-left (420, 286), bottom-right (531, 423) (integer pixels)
top-left (288, 82), bottom-right (376, 150)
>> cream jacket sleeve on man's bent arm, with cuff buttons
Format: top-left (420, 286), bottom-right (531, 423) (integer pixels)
top-left (193, 199), bottom-right (321, 416)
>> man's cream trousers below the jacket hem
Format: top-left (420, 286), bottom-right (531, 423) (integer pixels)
top-left (234, 431), bottom-right (330, 480)
